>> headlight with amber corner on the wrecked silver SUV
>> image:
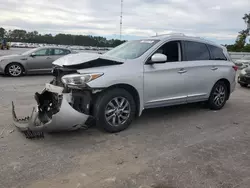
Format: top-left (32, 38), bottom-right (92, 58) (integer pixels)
top-left (62, 73), bottom-right (103, 87)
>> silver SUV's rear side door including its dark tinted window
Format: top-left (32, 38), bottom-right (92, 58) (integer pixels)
top-left (183, 41), bottom-right (216, 102)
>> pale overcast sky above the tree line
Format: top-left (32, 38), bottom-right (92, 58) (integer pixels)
top-left (0, 0), bottom-right (250, 43)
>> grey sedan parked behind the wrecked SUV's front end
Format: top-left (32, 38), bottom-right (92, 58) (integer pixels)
top-left (0, 47), bottom-right (72, 77)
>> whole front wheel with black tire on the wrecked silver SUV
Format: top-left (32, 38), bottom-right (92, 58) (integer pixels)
top-left (95, 88), bottom-right (136, 133)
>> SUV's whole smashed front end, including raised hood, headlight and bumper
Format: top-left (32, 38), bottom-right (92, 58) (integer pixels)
top-left (12, 53), bottom-right (123, 138)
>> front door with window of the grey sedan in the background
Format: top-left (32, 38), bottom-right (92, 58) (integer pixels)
top-left (27, 48), bottom-right (54, 72)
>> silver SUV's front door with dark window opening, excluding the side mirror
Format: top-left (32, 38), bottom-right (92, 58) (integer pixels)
top-left (144, 41), bottom-right (188, 108)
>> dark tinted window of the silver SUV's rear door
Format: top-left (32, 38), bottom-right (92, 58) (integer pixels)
top-left (184, 41), bottom-right (210, 61)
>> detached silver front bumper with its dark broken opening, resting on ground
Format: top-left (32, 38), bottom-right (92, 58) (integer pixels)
top-left (12, 84), bottom-right (89, 137)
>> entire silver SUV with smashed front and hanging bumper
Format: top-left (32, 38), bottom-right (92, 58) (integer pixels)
top-left (13, 34), bottom-right (237, 137)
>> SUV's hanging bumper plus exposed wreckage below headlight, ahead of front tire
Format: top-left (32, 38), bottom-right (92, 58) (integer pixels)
top-left (12, 67), bottom-right (91, 138)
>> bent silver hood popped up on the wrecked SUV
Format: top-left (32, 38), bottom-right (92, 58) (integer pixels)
top-left (53, 53), bottom-right (124, 69)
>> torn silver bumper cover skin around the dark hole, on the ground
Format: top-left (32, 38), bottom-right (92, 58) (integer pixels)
top-left (12, 85), bottom-right (89, 132)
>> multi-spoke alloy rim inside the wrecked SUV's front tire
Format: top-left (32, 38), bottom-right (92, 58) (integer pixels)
top-left (105, 97), bottom-right (131, 126)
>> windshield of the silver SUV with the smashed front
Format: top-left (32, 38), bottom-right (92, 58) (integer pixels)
top-left (104, 39), bottom-right (160, 59)
